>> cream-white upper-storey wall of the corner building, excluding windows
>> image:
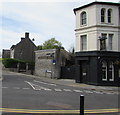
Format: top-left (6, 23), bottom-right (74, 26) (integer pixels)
top-left (75, 2), bottom-right (120, 52)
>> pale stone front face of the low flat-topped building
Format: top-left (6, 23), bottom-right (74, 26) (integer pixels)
top-left (35, 49), bottom-right (60, 78)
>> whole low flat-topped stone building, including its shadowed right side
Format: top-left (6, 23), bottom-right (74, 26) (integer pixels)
top-left (35, 49), bottom-right (71, 79)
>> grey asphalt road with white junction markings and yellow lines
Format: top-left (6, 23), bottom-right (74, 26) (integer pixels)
top-left (0, 72), bottom-right (118, 115)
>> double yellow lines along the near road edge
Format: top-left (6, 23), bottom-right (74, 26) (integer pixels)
top-left (0, 108), bottom-right (120, 114)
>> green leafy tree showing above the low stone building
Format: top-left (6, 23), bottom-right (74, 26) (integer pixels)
top-left (38, 38), bottom-right (64, 50)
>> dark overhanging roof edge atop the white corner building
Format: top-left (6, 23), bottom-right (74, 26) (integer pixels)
top-left (73, 1), bottom-right (120, 14)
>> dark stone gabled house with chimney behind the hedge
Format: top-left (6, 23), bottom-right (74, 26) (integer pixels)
top-left (10, 32), bottom-right (37, 62)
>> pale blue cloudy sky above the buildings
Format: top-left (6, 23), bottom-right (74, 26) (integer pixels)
top-left (0, 0), bottom-right (119, 51)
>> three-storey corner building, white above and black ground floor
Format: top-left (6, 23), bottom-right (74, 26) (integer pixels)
top-left (74, 1), bottom-right (120, 85)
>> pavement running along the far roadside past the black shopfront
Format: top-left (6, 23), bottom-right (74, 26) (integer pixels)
top-left (1, 71), bottom-right (120, 93)
